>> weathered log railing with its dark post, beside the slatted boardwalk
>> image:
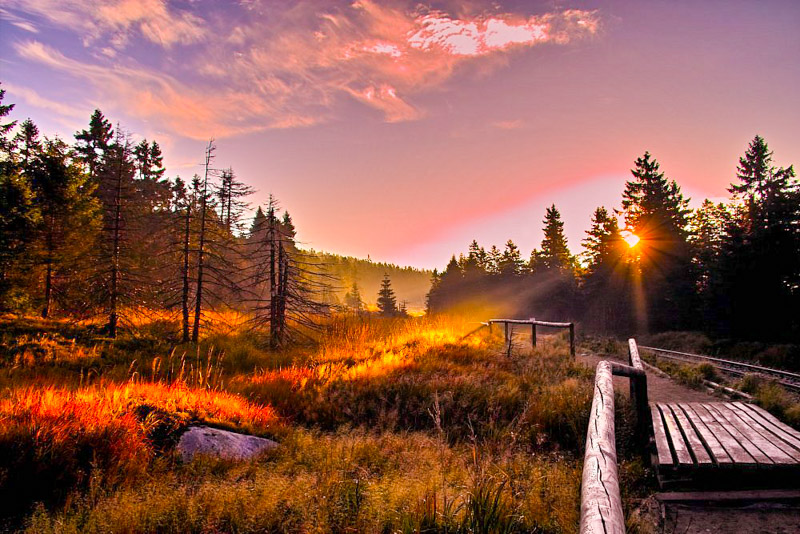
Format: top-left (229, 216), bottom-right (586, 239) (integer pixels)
top-left (580, 339), bottom-right (649, 534)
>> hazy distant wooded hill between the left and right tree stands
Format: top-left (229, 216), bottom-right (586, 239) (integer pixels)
top-left (308, 250), bottom-right (433, 311)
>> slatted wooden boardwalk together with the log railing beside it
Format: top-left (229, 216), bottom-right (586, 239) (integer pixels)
top-left (580, 339), bottom-right (800, 534)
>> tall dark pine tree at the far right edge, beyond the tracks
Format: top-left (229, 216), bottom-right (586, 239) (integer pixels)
top-left (710, 136), bottom-right (800, 340)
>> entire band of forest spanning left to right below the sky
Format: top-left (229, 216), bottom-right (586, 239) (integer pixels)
top-left (0, 80), bottom-right (800, 344)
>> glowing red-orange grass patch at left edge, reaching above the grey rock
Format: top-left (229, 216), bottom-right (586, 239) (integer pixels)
top-left (0, 381), bottom-right (283, 516)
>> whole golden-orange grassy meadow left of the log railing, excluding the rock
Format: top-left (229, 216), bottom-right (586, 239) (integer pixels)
top-left (0, 315), bottom-right (642, 533)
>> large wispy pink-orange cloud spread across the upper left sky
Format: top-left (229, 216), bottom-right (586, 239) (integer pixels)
top-left (9, 0), bottom-right (599, 138)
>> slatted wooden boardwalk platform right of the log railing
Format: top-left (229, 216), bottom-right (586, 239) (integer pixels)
top-left (650, 402), bottom-right (800, 485)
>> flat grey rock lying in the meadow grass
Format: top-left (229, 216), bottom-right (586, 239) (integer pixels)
top-left (177, 426), bottom-right (278, 462)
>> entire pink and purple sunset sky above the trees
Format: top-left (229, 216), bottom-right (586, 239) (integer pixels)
top-left (0, 0), bottom-right (800, 268)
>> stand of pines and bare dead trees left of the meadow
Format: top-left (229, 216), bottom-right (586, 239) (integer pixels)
top-left (0, 86), bottom-right (330, 346)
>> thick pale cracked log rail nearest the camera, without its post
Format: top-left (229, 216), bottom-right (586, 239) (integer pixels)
top-left (580, 361), bottom-right (625, 534)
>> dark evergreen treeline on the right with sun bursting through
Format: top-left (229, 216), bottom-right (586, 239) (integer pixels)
top-left (428, 136), bottom-right (800, 341)
